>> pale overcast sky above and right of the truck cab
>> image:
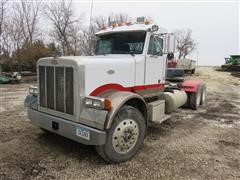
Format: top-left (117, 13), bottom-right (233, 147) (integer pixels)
top-left (73, 0), bottom-right (240, 65)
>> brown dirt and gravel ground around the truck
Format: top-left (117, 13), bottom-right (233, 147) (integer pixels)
top-left (0, 67), bottom-right (240, 179)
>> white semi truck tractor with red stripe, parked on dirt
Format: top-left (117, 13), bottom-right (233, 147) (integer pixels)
top-left (25, 18), bottom-right (206, 163)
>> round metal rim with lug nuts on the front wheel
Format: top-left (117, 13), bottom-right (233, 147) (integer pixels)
top-left (112, 119), bottom-right (139, 154)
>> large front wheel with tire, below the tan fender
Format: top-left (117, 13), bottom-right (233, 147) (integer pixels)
top-left (96, 105), bottom-right (146, 163)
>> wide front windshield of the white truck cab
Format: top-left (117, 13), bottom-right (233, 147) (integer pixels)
top-left (95, 32), bottom-right (146, 55)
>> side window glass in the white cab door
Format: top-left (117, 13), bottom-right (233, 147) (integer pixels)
top-left (148, 36), bottom-right (163, 55)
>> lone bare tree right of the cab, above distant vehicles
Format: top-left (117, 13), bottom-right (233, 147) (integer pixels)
top-left (174, 29), bottom-right (197, 59)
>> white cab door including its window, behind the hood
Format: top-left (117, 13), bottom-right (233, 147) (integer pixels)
top-left (145, 35), bottom-right (166, 85)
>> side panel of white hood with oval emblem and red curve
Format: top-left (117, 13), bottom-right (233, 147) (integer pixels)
top-left (80, 55), bottom-right (135, 96)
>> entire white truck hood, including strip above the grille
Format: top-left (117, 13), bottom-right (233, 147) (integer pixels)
top-left (38, 54), bottom-right (136, 96)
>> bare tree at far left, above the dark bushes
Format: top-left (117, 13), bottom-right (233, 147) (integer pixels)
top-left (1, 0), bottom-right (41, 69)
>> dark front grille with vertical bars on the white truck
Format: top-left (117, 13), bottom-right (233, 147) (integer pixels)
top-left (39, 66), bottom-right (74, 115)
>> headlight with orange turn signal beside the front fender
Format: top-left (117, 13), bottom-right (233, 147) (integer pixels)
top-left (85, 97), bottom-right (112, 110)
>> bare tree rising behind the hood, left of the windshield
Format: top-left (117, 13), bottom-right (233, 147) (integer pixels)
top-left (45, 1), bottom-right (80, 55)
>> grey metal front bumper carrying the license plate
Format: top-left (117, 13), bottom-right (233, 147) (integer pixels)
top-left (28, 107), bottom-right (106, 145)
